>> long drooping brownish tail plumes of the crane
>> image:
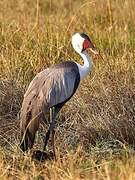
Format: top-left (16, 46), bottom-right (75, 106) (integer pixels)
top-left (20, 81), bottom-right (48, 151)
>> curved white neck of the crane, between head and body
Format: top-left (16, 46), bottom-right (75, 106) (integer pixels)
top-left (76, 51), bottom-right (92, 80)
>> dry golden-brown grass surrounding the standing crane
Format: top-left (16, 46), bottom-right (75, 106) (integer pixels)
top-left (0, 0), bottom-right (135, 180)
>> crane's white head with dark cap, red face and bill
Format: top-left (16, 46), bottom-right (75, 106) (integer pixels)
top-left (72, 33), bottom-right (99, 55)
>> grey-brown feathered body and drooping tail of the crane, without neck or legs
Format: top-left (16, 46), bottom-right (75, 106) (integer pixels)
top-left (20, 61), bottom-right (80, 153)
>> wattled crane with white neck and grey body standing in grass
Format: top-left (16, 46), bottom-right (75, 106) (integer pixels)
top-left (20, 33), bottom-right (100, 159)
